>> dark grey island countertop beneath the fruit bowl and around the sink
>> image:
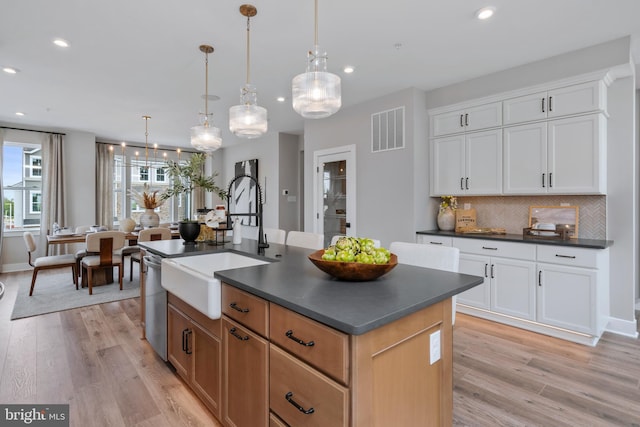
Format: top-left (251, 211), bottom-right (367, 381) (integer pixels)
top-left (139, 239), bottom-right (483, 335)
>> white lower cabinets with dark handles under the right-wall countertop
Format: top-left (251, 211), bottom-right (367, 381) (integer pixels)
top-left (448, 236), bottom-right (609, 345)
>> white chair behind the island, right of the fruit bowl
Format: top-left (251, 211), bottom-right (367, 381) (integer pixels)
top-left (389, 242), bottom-right (460, 324)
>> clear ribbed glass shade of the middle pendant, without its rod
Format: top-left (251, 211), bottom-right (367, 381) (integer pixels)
top-left (229, 84), bottom-right (268, 139)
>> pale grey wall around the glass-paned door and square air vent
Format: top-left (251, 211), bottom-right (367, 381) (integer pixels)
top-left (304, 88), bottom-right (428, 246)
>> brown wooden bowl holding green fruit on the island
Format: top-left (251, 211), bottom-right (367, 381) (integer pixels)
top-left (309, 249), bottom-right (398, 282)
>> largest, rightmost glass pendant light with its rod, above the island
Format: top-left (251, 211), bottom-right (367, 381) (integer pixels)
top-left (291, 0), bottom-right (342, 119)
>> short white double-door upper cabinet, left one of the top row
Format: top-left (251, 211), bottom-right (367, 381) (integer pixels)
top-left (431, 102), bottom-right (502, 136)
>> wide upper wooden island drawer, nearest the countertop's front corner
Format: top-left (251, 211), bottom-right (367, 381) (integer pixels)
top-left (269, 304), bottom-right (349, 385)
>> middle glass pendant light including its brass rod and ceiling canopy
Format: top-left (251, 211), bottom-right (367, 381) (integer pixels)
top-left (229, 4), bottom-right (267, 139)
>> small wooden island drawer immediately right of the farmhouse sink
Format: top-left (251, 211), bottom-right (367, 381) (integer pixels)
top-left (222, 283), bottom-right (269, 337)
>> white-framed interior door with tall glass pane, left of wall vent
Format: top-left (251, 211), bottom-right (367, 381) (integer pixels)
top-left (314, 146), bottom-right (356, 247)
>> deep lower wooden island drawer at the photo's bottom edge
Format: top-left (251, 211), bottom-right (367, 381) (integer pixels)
top-left (269, 344), bottom-right (349, 427)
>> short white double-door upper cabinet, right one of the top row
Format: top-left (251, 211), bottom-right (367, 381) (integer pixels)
top-left (503, 80), bottom-right (607, 126)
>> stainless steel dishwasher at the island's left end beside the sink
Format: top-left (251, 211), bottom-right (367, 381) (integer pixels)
top-left (144, 254), bottom-right (167, 362)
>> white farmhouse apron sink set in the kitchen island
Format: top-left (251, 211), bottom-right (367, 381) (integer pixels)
top-left (161, 252), bottom-right (268, 319)
